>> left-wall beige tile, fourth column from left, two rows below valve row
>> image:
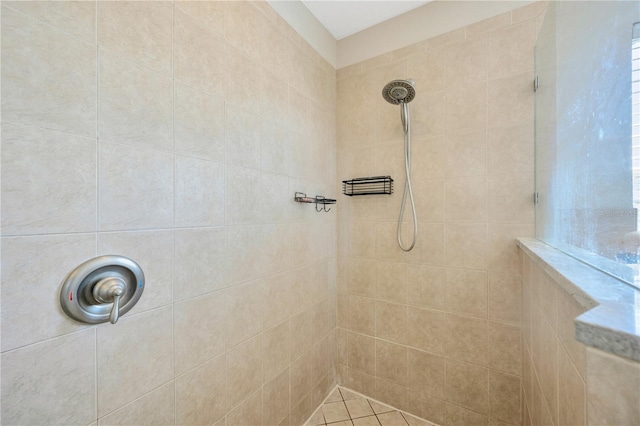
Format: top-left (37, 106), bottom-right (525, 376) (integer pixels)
top-left (226, 336), bottom-right (263, 411)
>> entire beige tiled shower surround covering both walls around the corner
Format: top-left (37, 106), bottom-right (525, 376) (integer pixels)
top-left (0, 0), bottom-right (636, 426)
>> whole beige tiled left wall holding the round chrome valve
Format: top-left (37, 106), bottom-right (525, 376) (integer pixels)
top-left (0, 1), bottom-right (340, 426)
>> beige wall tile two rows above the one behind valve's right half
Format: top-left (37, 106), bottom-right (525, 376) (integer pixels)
top-left (98, 52), bottom-right (173, 151)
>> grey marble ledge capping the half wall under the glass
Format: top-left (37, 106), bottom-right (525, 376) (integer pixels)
top-left (518, 238), bottom-right (640, 361)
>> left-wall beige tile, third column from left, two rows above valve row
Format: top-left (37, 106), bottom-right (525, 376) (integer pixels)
top-left (173, 82), bottom-right (225, 163)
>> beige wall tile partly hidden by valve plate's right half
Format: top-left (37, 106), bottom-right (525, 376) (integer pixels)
top-left (98, 231), bottom-right (174, 314)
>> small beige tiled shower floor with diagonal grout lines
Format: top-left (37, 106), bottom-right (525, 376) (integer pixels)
top-left (305, 386), bottom-right (436, 426)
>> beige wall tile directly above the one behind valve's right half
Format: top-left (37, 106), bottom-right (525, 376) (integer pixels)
top-left (98, 143), bottom-right (174, 231)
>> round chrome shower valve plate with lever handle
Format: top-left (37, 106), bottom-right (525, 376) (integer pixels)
top-left (60, 255), bottom-right (144, 324)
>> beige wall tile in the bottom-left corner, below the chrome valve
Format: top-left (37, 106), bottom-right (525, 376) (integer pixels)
top-left (1, 330), bottom-right (97, 424)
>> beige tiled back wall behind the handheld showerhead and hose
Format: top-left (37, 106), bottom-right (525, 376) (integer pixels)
top-left (336, 8), bottom-right (540, 426)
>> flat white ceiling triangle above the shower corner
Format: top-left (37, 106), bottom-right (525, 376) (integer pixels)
top-left (302, 0), bottom-right (431, 40)
